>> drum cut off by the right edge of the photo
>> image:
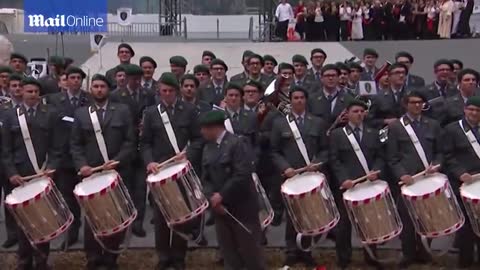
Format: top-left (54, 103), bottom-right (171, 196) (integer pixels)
top-left (460, 180), bottom-right (480, 236)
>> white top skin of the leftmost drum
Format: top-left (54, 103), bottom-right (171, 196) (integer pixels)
top-left (5, 177), bottom-right (50, 205)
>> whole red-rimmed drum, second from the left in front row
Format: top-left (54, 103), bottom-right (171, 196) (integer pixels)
top-left (73, 170), bottom-right (137, 237)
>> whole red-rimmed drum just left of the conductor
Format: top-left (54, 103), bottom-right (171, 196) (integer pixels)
top-left (147, 161), bottom-right (208, 226)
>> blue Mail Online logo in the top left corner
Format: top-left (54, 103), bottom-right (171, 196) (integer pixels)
top-left (24, 0), bottom-right (108, 33)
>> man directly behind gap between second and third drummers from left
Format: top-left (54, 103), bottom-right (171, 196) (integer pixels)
top-left (110, 64), bottom-right (155, 237)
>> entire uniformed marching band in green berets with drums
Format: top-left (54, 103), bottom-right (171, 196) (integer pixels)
top-left (0, 43), bottom-right (480, 270)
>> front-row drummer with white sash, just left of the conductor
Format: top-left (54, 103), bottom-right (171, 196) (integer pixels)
top-left (141, 72), bottom-right (202, 270)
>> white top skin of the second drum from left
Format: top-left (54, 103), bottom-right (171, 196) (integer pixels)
top-left (73, 171), bottom-right (118, 196)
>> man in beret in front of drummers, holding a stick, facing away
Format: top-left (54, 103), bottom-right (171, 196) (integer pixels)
top-left (200, 111), bottom-right (266, 270)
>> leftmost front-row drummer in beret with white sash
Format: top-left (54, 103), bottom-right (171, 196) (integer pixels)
top-left (2, 78), bottom-right (63, 270)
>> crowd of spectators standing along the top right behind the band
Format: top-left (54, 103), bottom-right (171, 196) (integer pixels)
top-left (275, 0), bottom-right (480, 41)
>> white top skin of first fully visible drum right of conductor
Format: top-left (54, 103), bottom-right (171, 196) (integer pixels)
top-left (282, 172), bottom-right (325, 195)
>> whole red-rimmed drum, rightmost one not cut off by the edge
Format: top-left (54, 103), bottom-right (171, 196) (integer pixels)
top-left (402, 173), bottom-right (465, 238)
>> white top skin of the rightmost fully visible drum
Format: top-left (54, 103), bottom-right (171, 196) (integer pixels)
top-left (402, 173), bottom-right (448, 197)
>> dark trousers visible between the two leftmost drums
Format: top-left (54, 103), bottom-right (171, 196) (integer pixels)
top-left (54, 168), bottom-right (82, 231)
